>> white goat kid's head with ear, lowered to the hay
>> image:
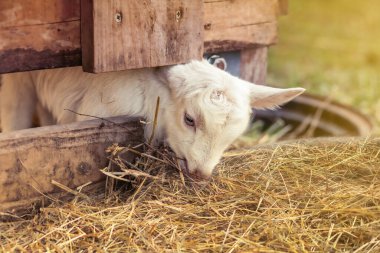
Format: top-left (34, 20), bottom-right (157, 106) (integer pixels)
top-left (161, 61), bottom-right (304, 179)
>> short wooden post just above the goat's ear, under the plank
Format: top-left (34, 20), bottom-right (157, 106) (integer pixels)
top-left (240, 46), bottom-right (268, 84)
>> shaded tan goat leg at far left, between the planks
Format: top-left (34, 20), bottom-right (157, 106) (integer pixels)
top-left (0, 72), bottom-right (37, 132)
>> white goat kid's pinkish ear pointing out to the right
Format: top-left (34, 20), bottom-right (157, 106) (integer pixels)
top-left (249, 84), bottom-right (305, 109)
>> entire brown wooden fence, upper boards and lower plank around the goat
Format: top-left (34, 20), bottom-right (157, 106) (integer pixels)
top-left (0, 0), bottom-right (287, 212)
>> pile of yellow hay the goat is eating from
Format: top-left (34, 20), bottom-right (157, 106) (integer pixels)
top-left (0, 139), bottom-right (380, 252)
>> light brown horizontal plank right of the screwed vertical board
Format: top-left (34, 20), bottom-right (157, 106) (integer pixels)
top-left (204, 0), bottom-right (279, 53)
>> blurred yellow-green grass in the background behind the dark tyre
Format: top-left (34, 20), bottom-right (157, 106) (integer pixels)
top-left (268, 0), bottom-right (380, 134)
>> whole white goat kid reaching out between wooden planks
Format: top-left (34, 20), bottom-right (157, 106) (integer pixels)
top-left (1, 61), bottom-right (304, 178)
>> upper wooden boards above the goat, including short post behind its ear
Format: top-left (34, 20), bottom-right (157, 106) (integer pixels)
top-left (0, 0), bottom-right (286, 81)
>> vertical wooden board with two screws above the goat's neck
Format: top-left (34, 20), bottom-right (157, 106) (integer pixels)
top-left (81, 0), bottom-right (203, 73)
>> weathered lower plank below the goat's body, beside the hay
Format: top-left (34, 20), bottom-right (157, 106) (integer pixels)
top-left (0, 117), bottom-right (143, 212)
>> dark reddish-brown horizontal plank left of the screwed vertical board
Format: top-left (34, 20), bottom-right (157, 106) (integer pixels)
top-left (0, 0), bottom-right (81, 73)
